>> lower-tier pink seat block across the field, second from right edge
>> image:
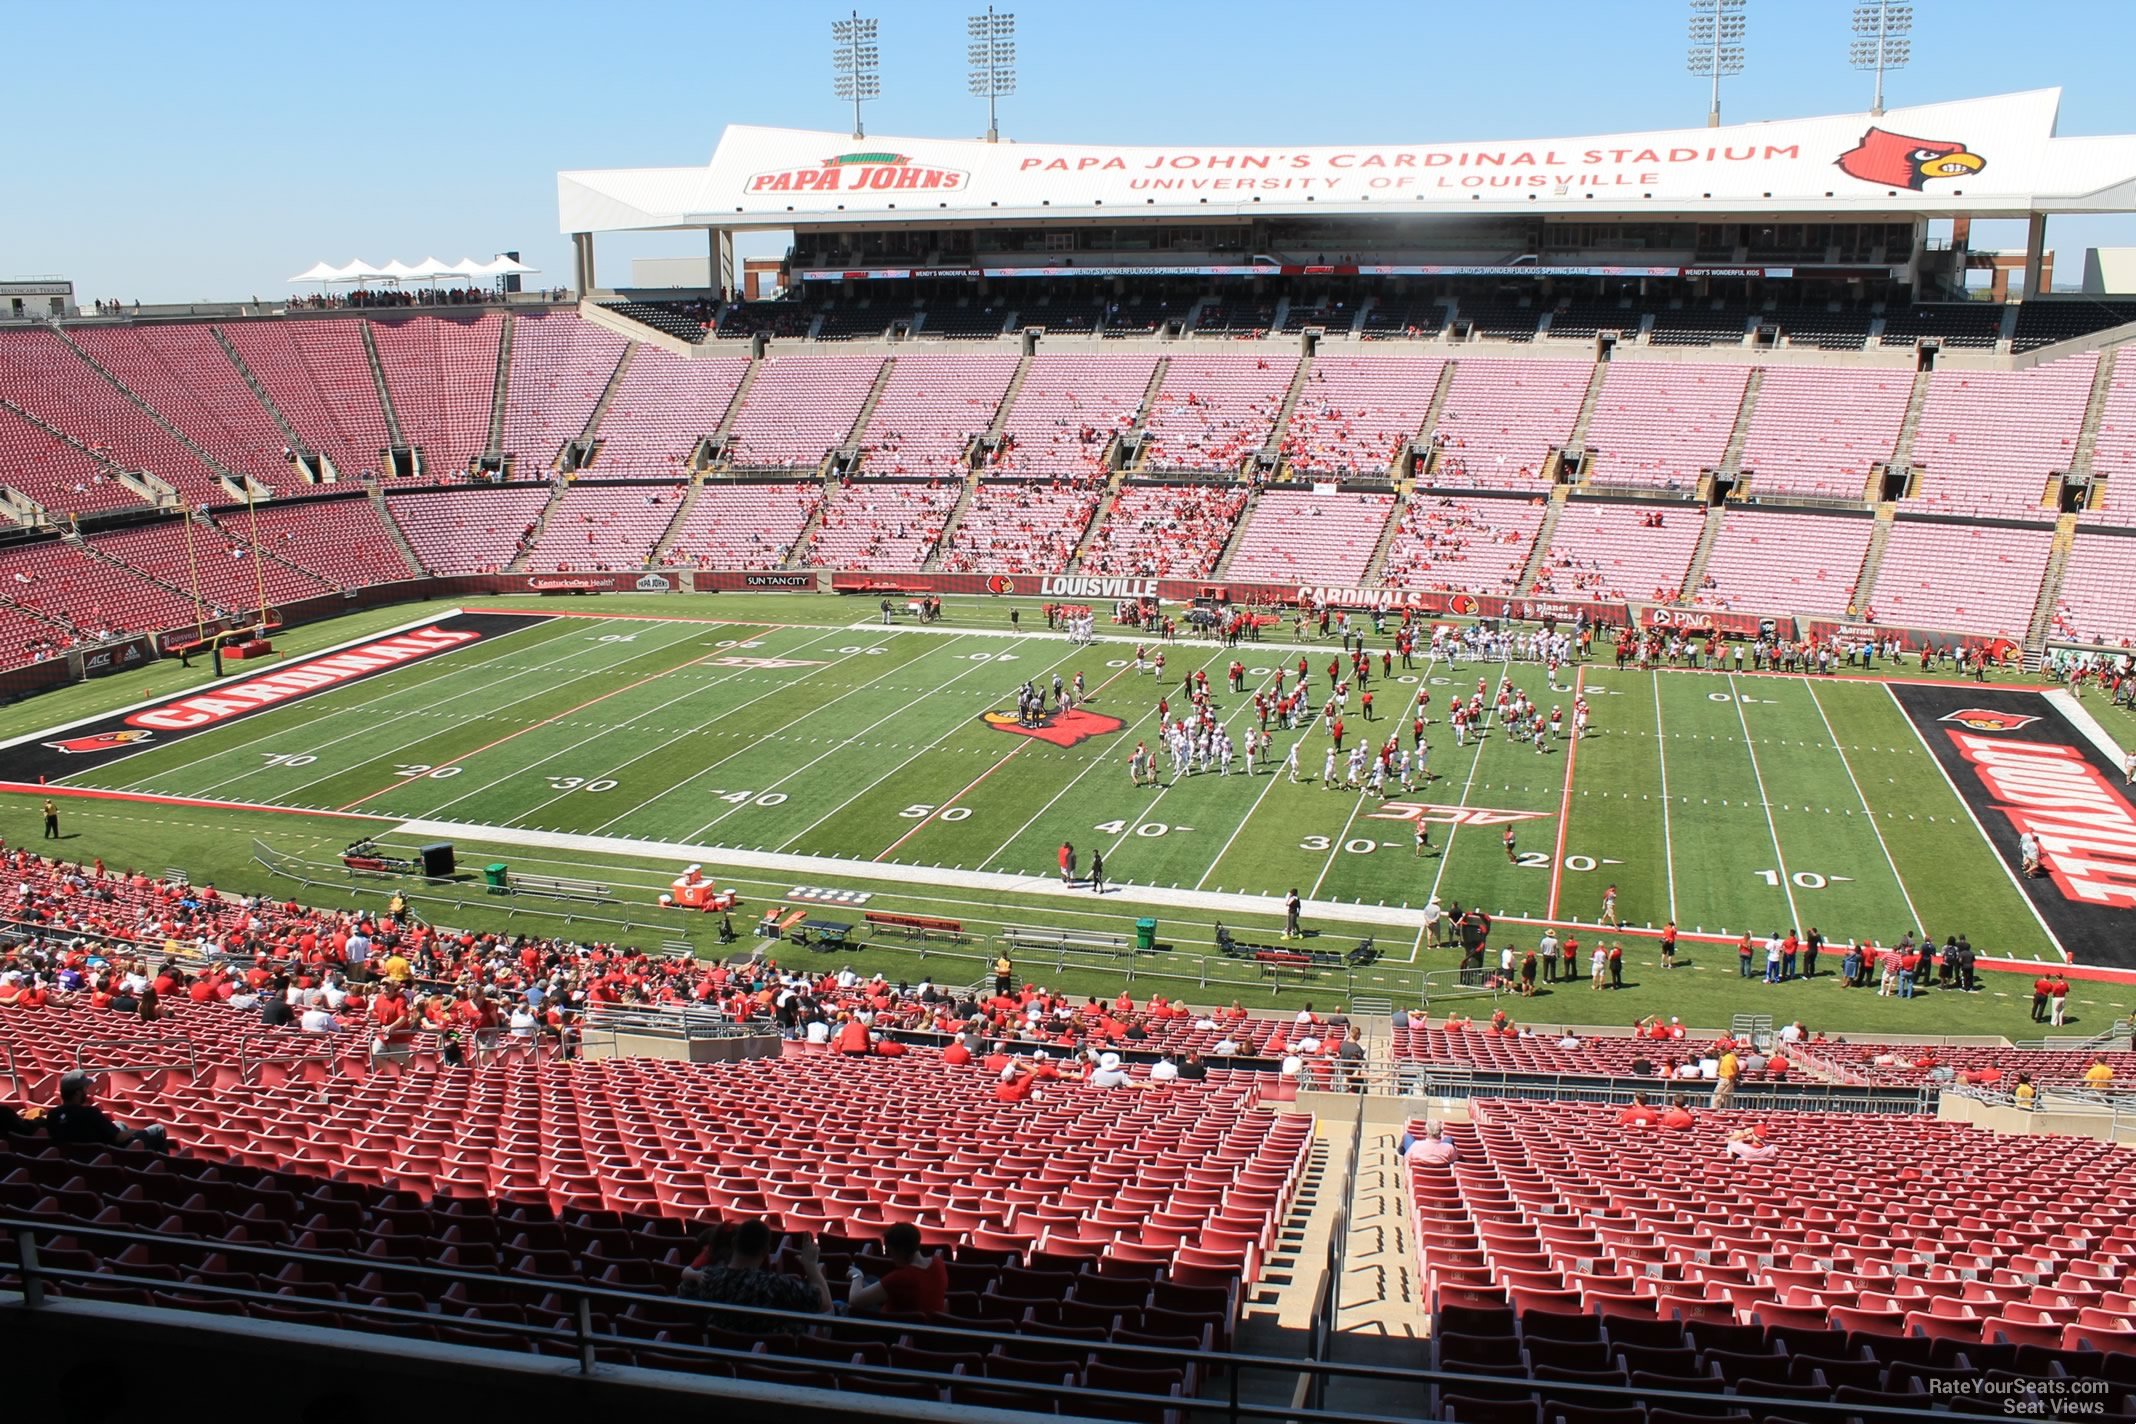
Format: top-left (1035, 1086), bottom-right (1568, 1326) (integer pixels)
top-left (1863, 519), bottom-right (2055, 638)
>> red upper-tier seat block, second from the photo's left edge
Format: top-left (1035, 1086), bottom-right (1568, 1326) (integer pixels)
top-left (73, 327), bottom-right (293, 489)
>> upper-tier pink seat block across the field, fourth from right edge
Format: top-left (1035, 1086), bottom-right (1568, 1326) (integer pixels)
top-left (1587, 361), bottom-right (1749, 491)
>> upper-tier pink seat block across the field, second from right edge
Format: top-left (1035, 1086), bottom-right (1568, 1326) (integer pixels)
top-left (1903, 352), bottom-right (2100, 520)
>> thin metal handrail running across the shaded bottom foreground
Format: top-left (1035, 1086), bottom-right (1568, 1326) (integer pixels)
top-left (0, 1215), bottom-right (1948, 1424)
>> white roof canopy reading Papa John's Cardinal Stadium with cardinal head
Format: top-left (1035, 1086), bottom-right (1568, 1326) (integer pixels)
top-left (555, 90), bottom-right (2136, 233)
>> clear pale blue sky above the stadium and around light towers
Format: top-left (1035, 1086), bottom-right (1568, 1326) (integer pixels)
top-left (0, 0), bottom-right (2136, 301)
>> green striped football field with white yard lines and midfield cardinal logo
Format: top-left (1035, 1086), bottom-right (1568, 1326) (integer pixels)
top-left (13, 600), bottom-right (2053, 956)
